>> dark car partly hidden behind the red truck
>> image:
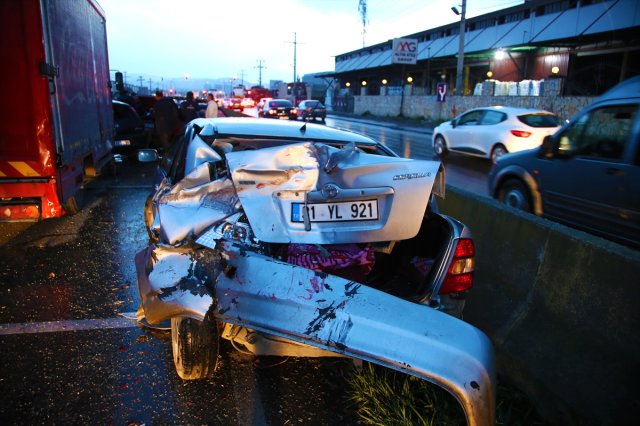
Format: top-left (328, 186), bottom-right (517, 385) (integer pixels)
top-left (112, 100), bottom-right (152, 158)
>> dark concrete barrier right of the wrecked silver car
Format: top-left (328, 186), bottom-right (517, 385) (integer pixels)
top-left (439, 186), bottom-right (640, 425)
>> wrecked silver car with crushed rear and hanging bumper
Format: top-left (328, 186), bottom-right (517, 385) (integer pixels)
top-left (136, 118), bottom-right (495, 425)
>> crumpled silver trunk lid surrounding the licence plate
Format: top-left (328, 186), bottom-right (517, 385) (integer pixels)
top-left (227, 143), bottom-right (440, 244)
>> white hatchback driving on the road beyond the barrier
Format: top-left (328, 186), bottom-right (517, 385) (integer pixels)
top-left (433, 106), bottom-right (560, 161)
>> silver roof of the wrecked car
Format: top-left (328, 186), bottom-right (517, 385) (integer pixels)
top-left (190, 117), bottom-right (378, 145)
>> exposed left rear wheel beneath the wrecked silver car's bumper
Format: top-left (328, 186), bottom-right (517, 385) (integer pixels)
top-left (171, 317), bottom-right (219, 380)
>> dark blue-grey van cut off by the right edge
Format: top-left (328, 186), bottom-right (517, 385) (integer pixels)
top-left (489, 77), bottom-right (640, 247)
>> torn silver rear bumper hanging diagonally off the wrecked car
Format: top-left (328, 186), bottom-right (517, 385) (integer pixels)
top-left (136, 241), bottom-right (495, 425)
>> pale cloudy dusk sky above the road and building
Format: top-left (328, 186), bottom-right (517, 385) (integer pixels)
top-left (98, 0), bottom-right (523, 85)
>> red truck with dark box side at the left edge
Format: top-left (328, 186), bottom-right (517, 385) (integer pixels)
top-left (0, 0), bottom-right (113, 221)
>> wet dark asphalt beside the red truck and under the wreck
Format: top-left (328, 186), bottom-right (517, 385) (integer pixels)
top-left (0, 163), bottom-right (357, 425)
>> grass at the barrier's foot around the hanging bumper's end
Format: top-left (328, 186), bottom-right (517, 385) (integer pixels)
top-left (347, 363), bottom-right (546, 426)
